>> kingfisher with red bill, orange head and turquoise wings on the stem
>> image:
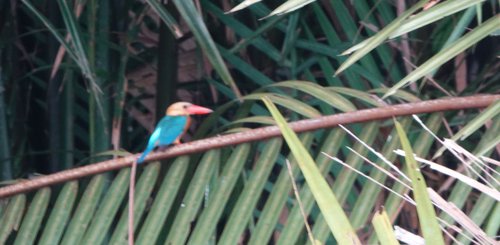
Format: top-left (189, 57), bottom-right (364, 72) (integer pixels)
top-left (137, 102), bottom-right (212, 164)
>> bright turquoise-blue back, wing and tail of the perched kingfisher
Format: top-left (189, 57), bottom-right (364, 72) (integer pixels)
top-left (137, 116), bottom-right (188, 163)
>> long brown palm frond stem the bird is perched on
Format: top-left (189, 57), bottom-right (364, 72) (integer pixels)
top-left (0, 95), bottom-right (500, 198)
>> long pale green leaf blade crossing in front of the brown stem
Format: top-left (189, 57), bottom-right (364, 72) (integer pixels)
top-left (262, 97), bottom-right (361, 244)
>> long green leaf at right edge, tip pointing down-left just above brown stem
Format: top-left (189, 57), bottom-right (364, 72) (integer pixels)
top-left (382, 14), bottom-right (500, 98)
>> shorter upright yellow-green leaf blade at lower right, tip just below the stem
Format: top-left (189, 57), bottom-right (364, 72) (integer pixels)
top-left (395, 121), bottom-right (444, 245)
